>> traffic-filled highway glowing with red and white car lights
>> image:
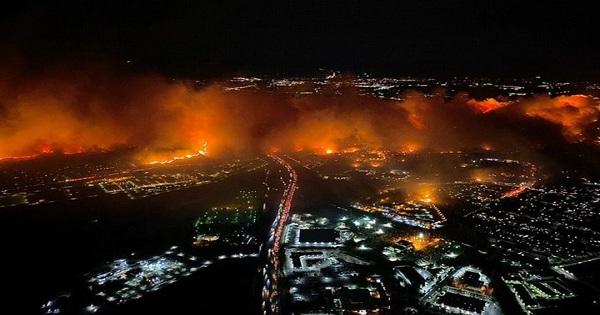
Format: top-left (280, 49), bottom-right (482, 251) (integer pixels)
top-left (262, 155), bottom-right (298, 314)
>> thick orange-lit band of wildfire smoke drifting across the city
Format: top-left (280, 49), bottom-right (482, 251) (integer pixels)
top-left (0, 67), bottom-right (600, 162)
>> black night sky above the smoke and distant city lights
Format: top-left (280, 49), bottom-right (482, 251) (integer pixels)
top-left (0, 0), bottom-right (600, 79)
